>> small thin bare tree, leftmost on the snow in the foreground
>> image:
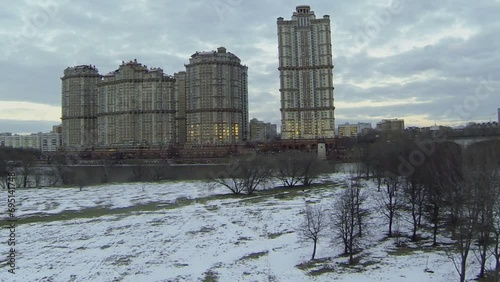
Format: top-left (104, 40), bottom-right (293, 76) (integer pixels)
top-left (298, 205), bottom-right (327, 260)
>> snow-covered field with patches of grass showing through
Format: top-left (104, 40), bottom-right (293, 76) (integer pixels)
top-left (0, 174), bottom-right (476, 282)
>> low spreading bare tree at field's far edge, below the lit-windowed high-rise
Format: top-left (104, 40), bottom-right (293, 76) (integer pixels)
top-left (209, 155), bottom-right (272, 195)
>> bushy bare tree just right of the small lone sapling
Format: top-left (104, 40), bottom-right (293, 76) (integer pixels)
top-left (332, 180), bottom-right (367, 264)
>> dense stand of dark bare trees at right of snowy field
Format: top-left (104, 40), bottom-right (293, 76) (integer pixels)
top-left (303, 132), bottom-right (500, 281)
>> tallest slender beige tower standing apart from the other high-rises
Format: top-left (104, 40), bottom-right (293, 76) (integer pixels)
top-left (278, 6), bottom-right (335, 139)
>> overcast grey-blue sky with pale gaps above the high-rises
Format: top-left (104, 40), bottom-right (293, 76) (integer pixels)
top-left (0, 0), bottom-right (500, 133)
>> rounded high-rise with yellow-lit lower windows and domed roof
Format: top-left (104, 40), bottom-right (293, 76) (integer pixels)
top-left (186, 47), bottom-right (248, 146)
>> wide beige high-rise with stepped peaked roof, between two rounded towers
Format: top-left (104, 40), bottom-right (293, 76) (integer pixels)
top-left (97, 60), bottom-right (175, 147)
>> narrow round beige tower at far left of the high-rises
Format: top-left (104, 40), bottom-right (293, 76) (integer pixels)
top-left (61, 65), bottom-right (101, 149)
